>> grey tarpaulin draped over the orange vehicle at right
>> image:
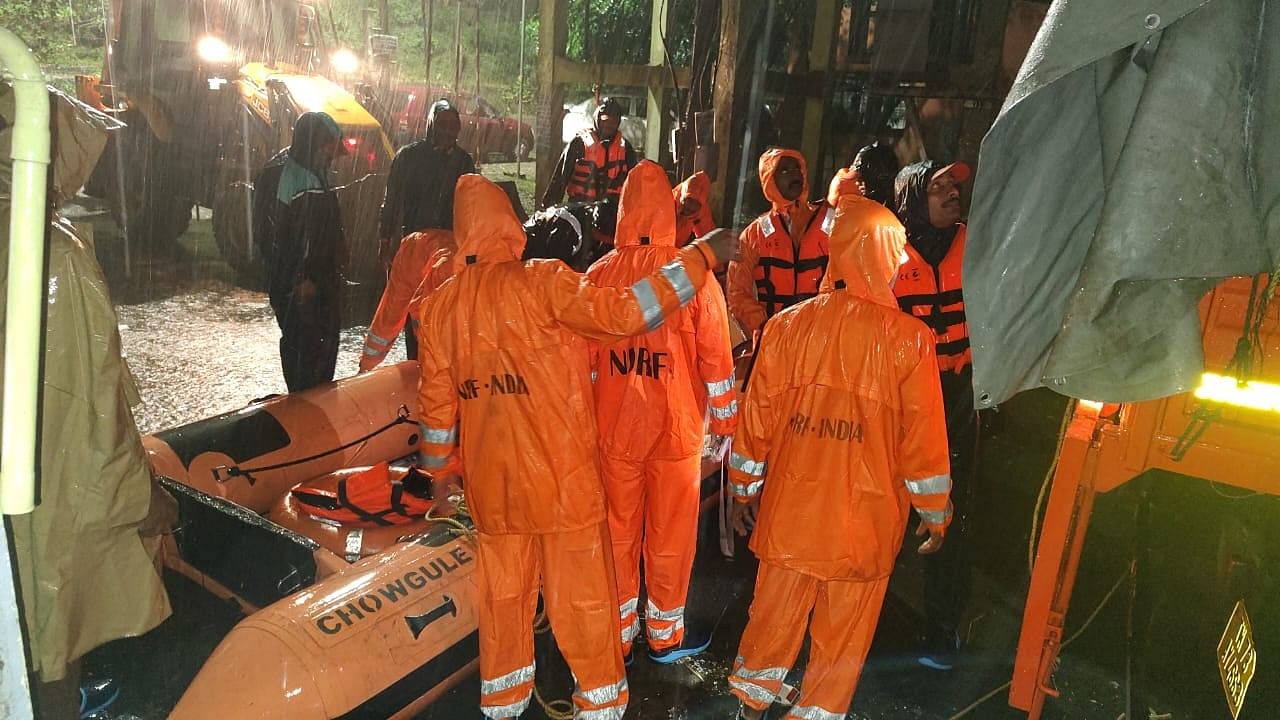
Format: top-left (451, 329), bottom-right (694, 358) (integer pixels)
top-left (964, 0), bottom-right (1280, 407)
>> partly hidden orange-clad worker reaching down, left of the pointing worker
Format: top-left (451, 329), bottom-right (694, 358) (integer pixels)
top-left (360, 229), bottom-right (457, 373)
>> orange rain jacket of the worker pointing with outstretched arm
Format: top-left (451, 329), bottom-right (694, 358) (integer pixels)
top-left (419, 174), bottom-right (716, 533)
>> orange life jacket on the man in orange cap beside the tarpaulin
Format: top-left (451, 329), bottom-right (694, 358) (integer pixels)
top-left (893, 225), bottom-right (973, 373)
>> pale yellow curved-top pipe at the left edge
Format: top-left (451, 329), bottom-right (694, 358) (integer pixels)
top-left (0, 28), bottom-right (49, 515)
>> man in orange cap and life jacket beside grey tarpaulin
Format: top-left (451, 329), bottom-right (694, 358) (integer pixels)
top-left (893, 161), bottom-right (978, 670)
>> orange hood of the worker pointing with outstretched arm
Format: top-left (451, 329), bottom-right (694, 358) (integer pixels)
top-left (453, 174), bottom-right (525, 273)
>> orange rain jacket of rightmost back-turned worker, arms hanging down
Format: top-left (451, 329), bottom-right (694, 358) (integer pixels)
top-left (730, 196), bottom-right (951, 580)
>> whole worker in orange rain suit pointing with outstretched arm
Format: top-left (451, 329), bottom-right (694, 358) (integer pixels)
top-left (419, 174), bottom-right (737, 720)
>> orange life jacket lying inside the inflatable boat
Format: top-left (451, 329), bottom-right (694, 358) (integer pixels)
top-left (289, 462), bottom-right (431, 525)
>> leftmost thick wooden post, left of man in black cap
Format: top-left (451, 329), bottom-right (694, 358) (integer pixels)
top-left (534, 0), bottom-right (568, 199)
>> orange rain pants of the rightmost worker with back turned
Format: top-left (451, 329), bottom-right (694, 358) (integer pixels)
top-left (728, 562), bottom-right (888, 720)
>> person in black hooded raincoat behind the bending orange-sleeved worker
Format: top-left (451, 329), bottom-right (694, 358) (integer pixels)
top-left (378, 100), bottom-right (476, 360)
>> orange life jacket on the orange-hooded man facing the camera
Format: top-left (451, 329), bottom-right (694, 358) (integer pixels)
top-left (754, 204), bottom-right (836, 318)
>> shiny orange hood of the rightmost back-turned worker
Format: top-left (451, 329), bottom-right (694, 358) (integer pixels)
top-left (822, 195), bottom-right (906, 307)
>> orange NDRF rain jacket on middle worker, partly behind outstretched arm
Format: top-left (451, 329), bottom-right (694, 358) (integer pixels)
top-left (586, 160), bottom-right (737, 460)
